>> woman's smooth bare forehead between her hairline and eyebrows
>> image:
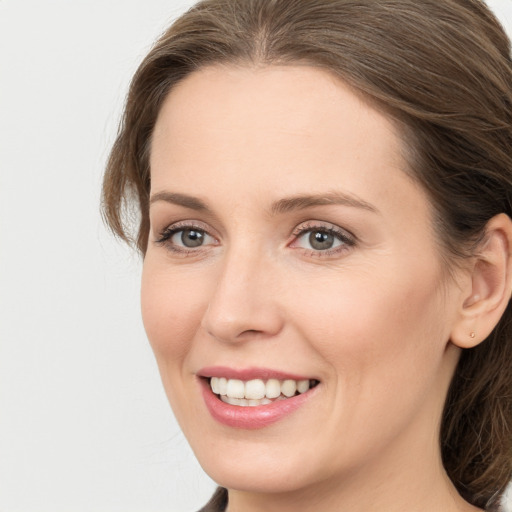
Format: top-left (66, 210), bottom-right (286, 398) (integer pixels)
top-left (151, 65), bottom-right (416, 212)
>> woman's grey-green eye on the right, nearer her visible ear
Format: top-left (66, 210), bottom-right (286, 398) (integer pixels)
top-left (291, 224), bottom-right (355, 254)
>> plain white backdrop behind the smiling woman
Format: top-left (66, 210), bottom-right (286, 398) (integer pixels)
top-left (0, 0), bottom-right (512, 512)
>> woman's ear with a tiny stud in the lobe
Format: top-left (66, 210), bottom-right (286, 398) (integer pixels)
top-left (450, 213), bottom-right (512, 348)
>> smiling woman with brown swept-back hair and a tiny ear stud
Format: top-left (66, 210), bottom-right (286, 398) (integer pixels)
top-left (103, 0), bottom-right (512, 512)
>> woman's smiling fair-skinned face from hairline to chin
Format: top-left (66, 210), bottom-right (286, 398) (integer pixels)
top-left (142, 66), bottom-right (461, 492)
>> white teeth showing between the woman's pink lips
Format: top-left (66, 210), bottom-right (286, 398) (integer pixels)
top-left (207, 377), bottom-right (319, 407)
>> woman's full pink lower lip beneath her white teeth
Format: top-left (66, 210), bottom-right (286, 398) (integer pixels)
top-left (200, 379), bottom-right (318, 430)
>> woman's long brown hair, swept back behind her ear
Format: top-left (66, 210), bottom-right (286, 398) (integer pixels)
top-left (103, 0), bottom-right (512, 509)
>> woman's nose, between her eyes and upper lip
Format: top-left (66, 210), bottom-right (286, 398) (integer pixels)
top-left (201, 248), bottom-right (283, 343)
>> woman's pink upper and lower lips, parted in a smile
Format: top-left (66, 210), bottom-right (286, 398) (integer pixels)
top-left (198, 367), bottom-right (319, 430)
